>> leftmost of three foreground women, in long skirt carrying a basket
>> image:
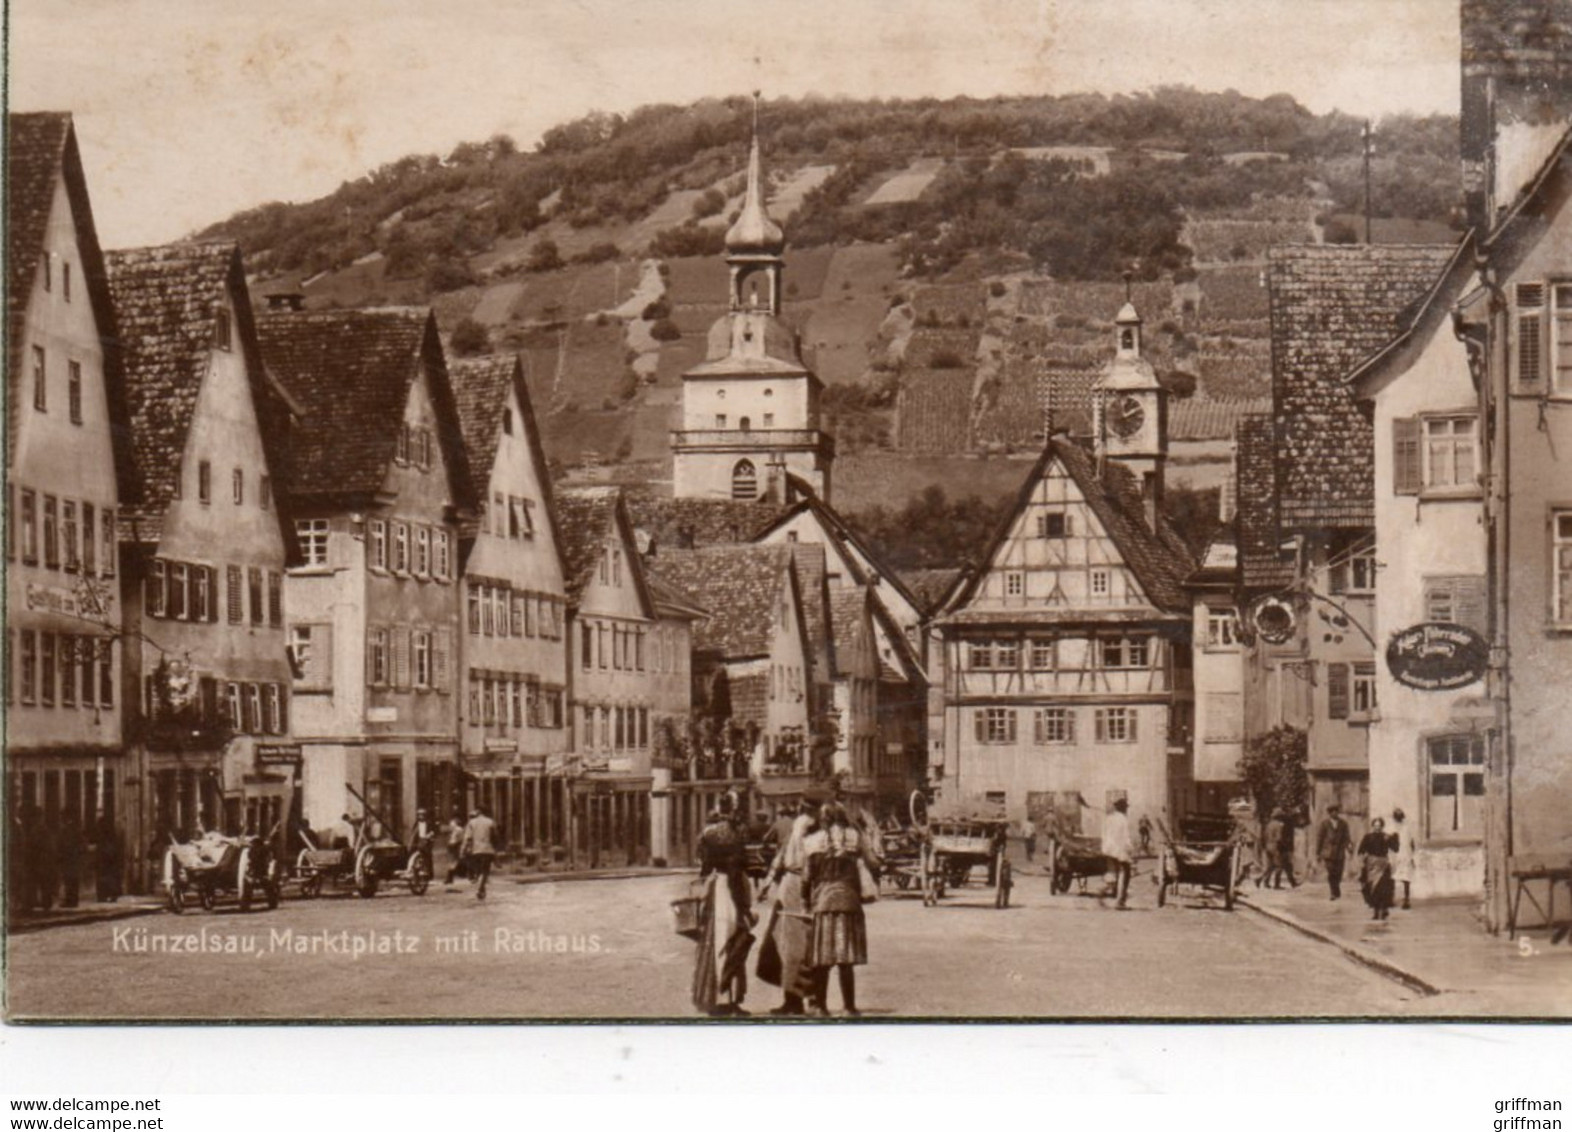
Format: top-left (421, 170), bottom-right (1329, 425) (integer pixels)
top-left (693, 810), bottom-right (753, 1016)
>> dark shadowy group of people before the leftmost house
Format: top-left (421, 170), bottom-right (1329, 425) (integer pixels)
top-left (6, 805), bottom-right (124, 912)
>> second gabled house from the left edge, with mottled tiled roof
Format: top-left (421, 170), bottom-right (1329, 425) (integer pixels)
top-left (108, 244), bottom-right (299, 844)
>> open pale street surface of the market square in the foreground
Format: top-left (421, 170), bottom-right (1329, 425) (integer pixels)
top-left (8, 876), bottom-right (1445, 1019)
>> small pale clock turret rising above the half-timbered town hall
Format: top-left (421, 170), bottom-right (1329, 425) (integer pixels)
top-left (1093, 302), bottom-right (1168, 530)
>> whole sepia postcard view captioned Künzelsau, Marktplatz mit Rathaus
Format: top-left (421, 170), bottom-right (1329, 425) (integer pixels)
top-left (3, 0), bottom-right (1572, 1025)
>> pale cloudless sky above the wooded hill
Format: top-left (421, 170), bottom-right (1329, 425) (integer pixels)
top-left (8, 0), bottom-right (1457, 247)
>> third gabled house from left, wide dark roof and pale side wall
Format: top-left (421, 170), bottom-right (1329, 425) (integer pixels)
top-left (258, 308), bottom-right (478, 836)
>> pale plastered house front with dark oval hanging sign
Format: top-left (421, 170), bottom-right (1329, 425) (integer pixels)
top-left (1352, 242), bottom-right (1489, 898)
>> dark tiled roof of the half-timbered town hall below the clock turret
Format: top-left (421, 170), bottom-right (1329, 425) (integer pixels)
top-left (945, 437), bottom-right (1195, 621)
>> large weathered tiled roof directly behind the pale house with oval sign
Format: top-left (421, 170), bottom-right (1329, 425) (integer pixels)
top-left (1267, 244), bottom-right (1453, 528)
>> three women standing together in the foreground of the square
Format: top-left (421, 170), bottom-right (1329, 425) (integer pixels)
top-left (693, 799), bottom-right (882, 1017)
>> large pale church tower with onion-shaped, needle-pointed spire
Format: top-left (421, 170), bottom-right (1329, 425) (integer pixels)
top-left (671, 111), bottom-right (835, 502)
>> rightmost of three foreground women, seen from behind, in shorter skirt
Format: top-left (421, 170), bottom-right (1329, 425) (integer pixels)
top-left (805, 802), bottom-right (879, 1017)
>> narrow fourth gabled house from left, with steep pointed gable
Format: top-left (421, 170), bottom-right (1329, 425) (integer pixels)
top-left (451, 355), bottom-right (569, 849)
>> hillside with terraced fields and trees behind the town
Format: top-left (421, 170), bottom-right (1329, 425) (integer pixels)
top-left (201, 90), bottom-right (1457, 525)
